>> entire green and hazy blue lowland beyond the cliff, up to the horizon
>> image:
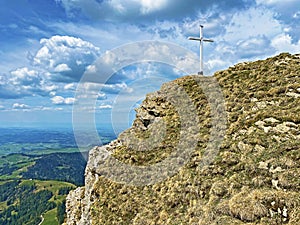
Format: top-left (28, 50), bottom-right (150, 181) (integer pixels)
top-left (0, 128), bottom-right (114, 225)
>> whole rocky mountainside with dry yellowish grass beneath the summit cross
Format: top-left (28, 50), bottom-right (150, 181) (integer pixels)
top-left (66, 53), bottom-right (300, 225)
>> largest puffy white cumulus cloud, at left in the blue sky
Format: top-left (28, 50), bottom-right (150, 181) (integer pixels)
top-left (32, 35), bottom-right (100, 82)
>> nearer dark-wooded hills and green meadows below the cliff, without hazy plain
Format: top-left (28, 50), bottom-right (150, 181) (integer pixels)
top-left (0, 152), bottom-right (87, 225)
